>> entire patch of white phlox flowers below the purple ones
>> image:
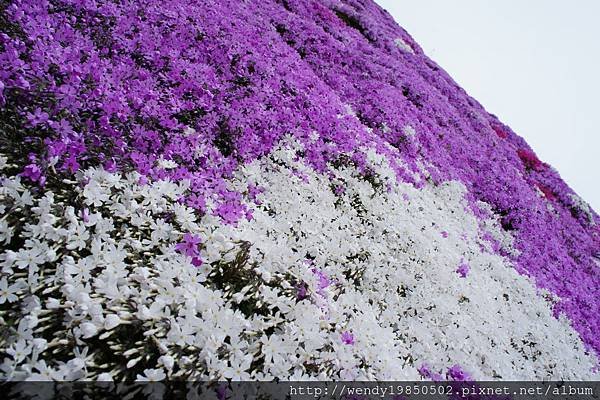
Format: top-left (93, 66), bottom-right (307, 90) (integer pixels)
top-left (0, 143), bottom-right (596, 381)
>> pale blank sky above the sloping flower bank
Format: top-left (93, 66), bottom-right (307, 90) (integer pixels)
top-left (376, 0), bottom-right (600, 212)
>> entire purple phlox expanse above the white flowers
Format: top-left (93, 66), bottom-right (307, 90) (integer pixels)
top-left (0, 0), bottom-right (600, 354)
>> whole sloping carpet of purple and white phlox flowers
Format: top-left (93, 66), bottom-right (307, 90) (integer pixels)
top-left (0, 0), bottom-right (600, 381)
